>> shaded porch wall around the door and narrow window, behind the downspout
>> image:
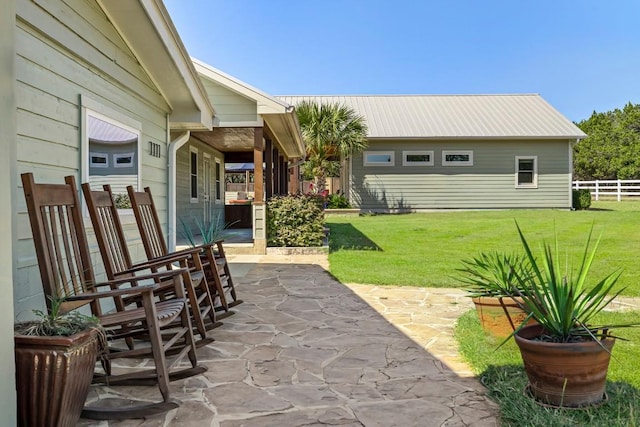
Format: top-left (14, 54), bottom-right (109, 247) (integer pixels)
top-left (176, 138), bottom-right (224, 242)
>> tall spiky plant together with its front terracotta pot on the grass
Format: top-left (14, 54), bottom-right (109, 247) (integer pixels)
top-left (513, 223), bottom-right (637, 407)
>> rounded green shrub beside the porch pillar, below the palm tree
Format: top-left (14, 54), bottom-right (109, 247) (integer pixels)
top-left (267, 195), bottom-right (324, 247)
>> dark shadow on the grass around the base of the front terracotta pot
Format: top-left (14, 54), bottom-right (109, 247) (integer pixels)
top-left (479, 365), bottom-right (640, 427)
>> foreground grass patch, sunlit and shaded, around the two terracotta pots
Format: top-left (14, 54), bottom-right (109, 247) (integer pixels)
top-left (455, 310), bottom-right (640, 427)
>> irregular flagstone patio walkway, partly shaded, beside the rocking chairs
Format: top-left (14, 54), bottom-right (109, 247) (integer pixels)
top-left (80, 255), bottom-right (498, 427)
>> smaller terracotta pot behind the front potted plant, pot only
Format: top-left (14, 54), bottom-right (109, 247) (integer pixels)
top-left (471, 297), bottom-right (533, 338)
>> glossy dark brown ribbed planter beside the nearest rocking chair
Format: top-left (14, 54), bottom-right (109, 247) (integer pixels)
top-left (14, 330), bottom-right (98, 426)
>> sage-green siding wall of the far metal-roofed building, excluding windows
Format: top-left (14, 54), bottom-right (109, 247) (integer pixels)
top-left (349, 140), bottom-right (571, 212)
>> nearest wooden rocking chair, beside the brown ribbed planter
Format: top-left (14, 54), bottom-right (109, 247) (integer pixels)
top-left (22, 173), bottom-right (206, 419)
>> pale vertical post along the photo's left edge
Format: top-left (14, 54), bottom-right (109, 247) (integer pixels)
top-left (0, 0), bottom-right (18, 426)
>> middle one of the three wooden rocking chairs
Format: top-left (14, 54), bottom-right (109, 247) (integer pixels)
top-left (82, 183), bottom-right (221, 347)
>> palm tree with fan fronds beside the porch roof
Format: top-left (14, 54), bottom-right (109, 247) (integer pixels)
top-left (296, 101), bottom-right (367, 192)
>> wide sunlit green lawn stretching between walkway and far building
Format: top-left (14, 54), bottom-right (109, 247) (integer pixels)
top-left (327, 201), bottom-right (640, 296)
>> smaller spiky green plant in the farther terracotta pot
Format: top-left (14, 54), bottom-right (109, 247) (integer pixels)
top-left (457, 251), bottom-right (531, 297)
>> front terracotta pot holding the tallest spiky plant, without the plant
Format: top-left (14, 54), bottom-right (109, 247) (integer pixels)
top-left (515, 325), bottom-right (615, 407)
